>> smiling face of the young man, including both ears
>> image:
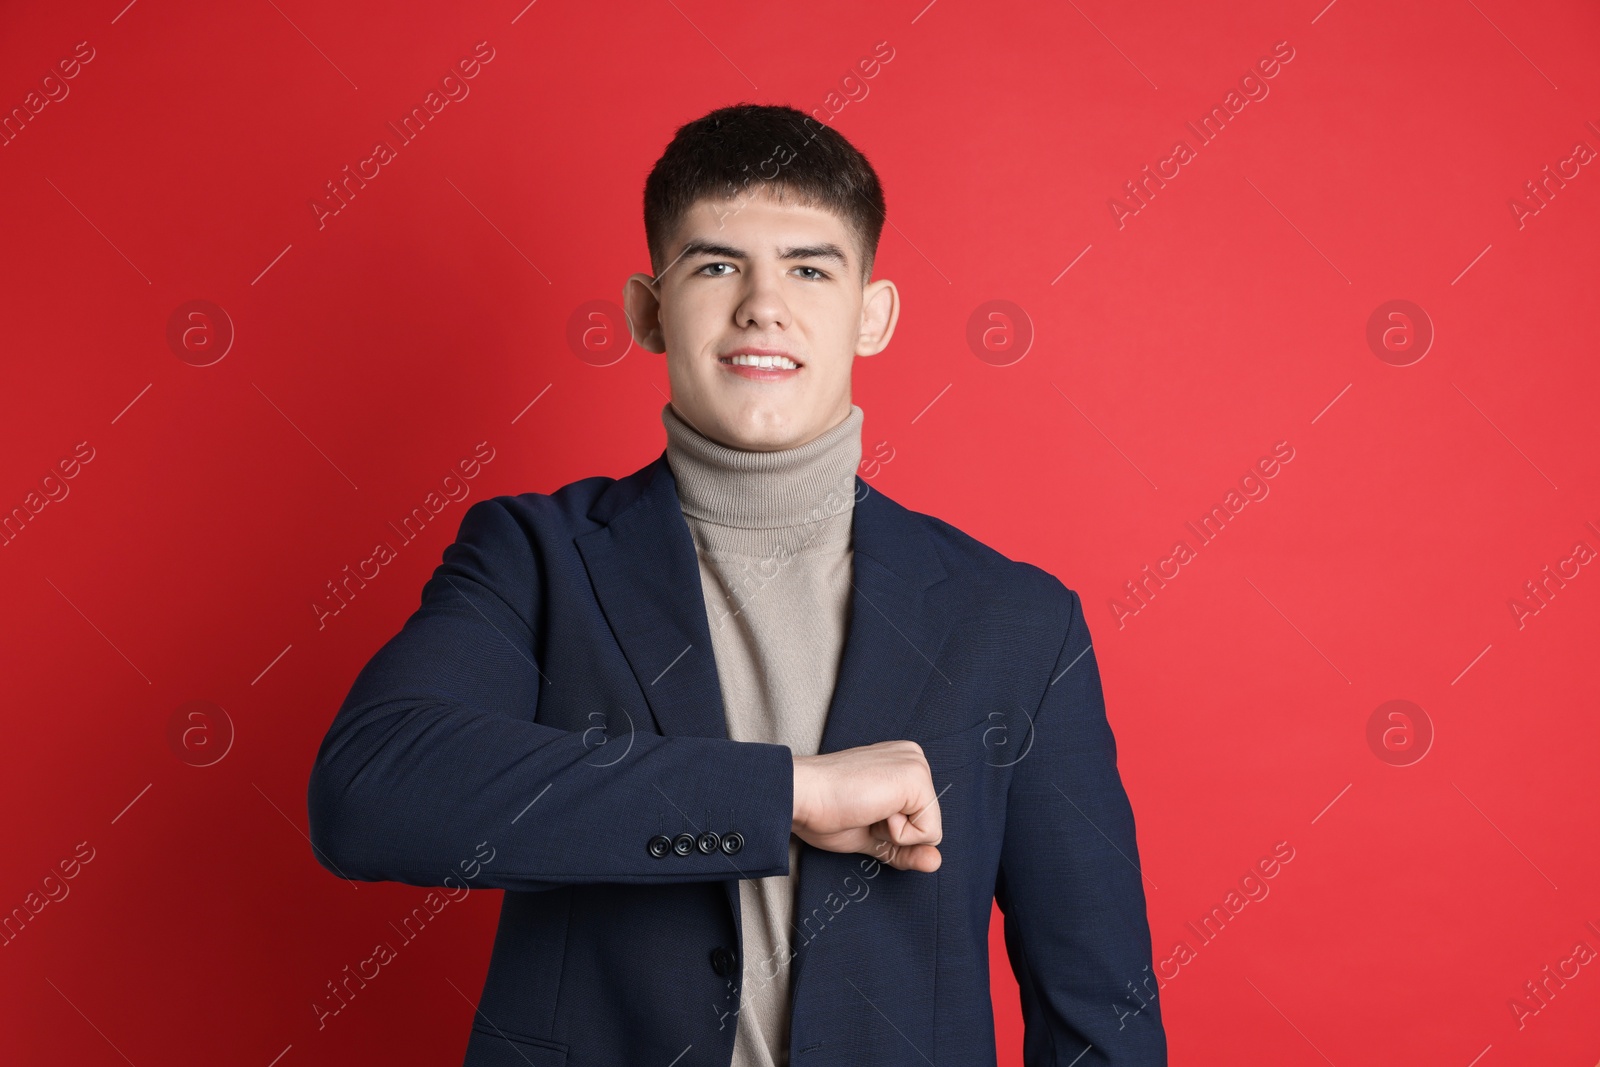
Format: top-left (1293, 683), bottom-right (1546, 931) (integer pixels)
top-left (624, 194), bottom-right (899, 451)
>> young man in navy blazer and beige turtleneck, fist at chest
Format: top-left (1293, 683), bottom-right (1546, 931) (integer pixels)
top-left (309, 106), bottom-right (1166, 1067)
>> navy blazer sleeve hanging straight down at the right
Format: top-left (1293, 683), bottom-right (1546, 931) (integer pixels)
top-left (995, 582), bottom-right (1166, 1067)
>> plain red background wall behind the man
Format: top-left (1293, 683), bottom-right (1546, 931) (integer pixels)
top-left (0, 0), bottom-right (1600, 1067)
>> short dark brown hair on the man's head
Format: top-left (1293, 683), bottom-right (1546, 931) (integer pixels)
top-left (645, 104), bottom-right (886, 285)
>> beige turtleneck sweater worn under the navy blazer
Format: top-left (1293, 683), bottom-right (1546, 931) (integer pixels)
top-left (661, 403), bottom-right (864, 1067)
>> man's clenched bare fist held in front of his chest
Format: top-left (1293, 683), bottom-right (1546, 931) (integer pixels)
top-left (794, 741), bottom-right (944, 872)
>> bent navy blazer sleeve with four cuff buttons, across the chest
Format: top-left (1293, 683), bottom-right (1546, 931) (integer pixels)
top-left (307, 498), bottom-right (794, 891)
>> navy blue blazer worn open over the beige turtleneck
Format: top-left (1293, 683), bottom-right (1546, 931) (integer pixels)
top-left (307, 453), bottom-right (1166, 1067)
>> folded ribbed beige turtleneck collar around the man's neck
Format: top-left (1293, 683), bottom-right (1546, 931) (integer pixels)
top-left (661, 403), bottom-right (866, 542)
